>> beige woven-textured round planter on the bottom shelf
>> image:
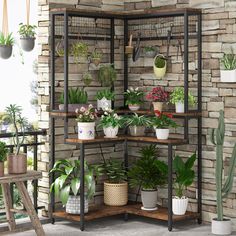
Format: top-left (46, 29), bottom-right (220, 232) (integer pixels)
top-left (104, 182), bottom-right (128, 206)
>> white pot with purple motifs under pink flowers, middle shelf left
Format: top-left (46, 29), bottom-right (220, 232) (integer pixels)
top-left (78, 122), bottom-right (95, 140)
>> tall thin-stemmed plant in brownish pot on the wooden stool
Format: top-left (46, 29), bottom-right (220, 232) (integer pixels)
top-left (6, 104), bottom-right (28, 174)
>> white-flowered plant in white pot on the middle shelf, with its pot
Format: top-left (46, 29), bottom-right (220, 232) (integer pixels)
top-left (98, 109), bottom-right (124, 138)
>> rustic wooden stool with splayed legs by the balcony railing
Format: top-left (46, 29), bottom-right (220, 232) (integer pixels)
top-left (0, 171), bottom-right (45, 236)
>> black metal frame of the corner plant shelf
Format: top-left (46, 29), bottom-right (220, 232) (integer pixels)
top-left (50, 9), bottom-right (202, 231)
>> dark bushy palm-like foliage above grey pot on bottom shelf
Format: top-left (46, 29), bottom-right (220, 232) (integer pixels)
top-left (128, 145), bottom-right (168, 190)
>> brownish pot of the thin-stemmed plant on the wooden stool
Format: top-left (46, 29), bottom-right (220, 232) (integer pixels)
top-left (7, 153), bottom-right (27, 174)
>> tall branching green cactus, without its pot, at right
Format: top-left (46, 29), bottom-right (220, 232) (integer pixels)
top-left (211, 110), bottom-right (236, 221)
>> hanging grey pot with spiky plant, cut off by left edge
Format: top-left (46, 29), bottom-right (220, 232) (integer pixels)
top-left (0, 32), bottom-right (14, 59)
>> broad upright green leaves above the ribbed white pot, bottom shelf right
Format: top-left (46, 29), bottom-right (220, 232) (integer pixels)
top-left (173, 153), bottom-right (196, 198)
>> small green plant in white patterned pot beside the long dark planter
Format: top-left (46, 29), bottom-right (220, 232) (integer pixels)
top-left (96, 89), bottom-right (115, 110)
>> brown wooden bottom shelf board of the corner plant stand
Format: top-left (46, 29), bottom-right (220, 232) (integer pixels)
top-left (53, 203), bottom-right (199, 222)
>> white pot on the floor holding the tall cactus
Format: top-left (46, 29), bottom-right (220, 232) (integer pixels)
top-left (211, 218), bottom-right (232, 235)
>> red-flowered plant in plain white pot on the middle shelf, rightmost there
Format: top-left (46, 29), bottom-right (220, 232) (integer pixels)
top-left (152, 111), bottom-right (177, 139)
